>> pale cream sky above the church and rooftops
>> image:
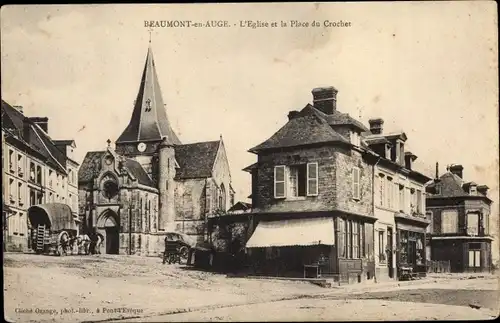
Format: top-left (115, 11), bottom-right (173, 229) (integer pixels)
top-left (1, 1), bottom-right (499, 260)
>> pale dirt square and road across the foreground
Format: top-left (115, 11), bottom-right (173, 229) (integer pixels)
top-left (4, 254), bottom-right (498, 322)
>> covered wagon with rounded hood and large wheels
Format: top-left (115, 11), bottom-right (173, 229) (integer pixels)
top-left (28, 203), bottom-right (79, 256)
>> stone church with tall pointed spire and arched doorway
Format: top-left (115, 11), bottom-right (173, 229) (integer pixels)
top-left (78, 45), bottom-right (234, 256)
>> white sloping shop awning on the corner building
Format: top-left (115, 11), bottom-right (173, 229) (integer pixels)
top-left (246, 217), bottom-right (335, 248)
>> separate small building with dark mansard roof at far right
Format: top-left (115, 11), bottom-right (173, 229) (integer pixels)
top-left (427, 164), bottom-right (493, 272)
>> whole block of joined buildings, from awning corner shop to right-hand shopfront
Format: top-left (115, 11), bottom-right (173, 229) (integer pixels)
top-left (235, 87), bottom-right (430, 282)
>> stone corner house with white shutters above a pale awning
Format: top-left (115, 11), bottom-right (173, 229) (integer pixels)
top-left (245, 87), bottom-right (376, 282)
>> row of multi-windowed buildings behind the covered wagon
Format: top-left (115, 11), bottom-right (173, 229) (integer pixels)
top-left (2, 100), bottom-right (78, 251)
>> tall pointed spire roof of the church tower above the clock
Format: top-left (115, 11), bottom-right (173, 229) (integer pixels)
top-left (116, 45), bottom-right (181, 145)
